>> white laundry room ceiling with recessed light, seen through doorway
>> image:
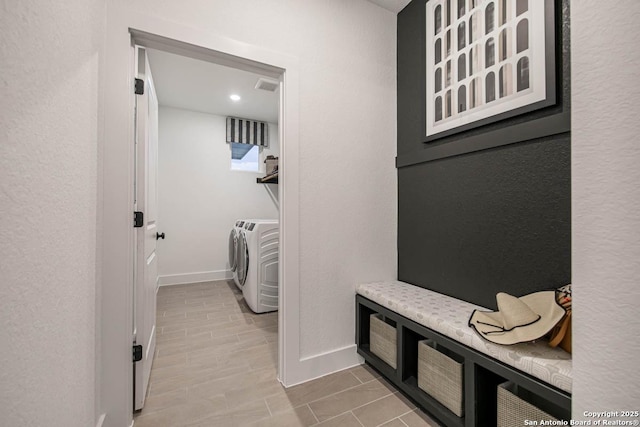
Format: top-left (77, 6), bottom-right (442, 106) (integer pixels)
top-left (147, 49), bottom-right (279, 123)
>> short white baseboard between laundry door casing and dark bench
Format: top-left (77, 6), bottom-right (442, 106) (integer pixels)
top-left (284, 344), bottom-right (364, 387)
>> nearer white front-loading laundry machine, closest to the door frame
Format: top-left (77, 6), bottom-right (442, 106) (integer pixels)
top-left (236, 220), bottom-right (280, 313)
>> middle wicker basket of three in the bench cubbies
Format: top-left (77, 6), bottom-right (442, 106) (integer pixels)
top-left (418, 340), bottom-right (464, 417)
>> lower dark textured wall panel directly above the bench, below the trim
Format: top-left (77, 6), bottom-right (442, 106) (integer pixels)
top-left (398, 137), bottom-right (571, 307)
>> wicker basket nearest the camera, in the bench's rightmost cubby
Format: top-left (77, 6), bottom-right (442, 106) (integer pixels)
top-left (498, 382), bottom-right (558, 427)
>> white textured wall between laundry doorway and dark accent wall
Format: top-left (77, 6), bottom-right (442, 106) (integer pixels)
top-left (114, 0), bottom-right (397, 357)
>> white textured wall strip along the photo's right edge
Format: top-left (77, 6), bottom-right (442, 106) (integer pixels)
top-left (571, 0), bottom-right (640, 419)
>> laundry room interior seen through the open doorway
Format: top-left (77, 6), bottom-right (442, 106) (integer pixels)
top-left (136, 48), bottom-right (280, 414)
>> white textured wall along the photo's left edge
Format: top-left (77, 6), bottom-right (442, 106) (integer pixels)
top-left (0, 0), bottom-right (105, 427)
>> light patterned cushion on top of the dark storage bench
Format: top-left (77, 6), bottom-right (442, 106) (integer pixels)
top-left (356, 280), bottom-right (572, 393)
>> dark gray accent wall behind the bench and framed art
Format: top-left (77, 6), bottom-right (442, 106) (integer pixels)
top-left (398, 0), bottom-right (571, 308)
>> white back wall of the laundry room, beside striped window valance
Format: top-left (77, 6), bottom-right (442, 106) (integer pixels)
top-left (158, 107), bottom-right (280, 285)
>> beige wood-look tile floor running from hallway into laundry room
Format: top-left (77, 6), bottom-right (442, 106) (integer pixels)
top-left (134, 281), bottom-right (437, 427)
